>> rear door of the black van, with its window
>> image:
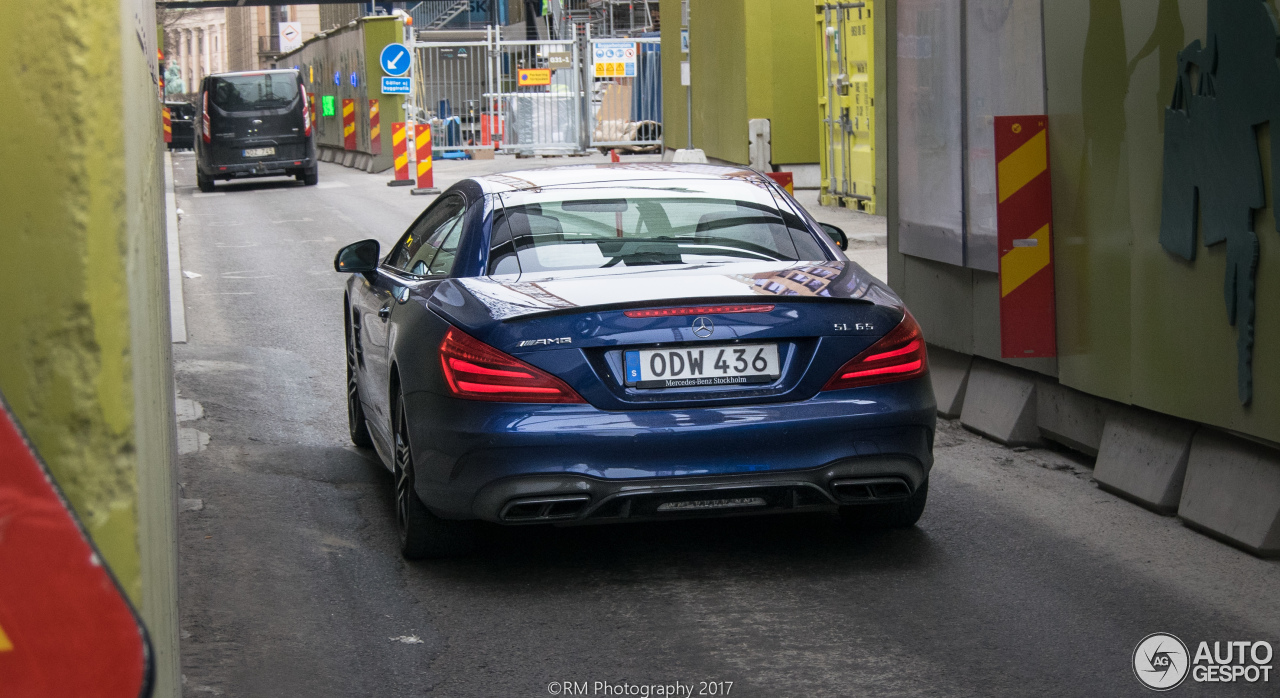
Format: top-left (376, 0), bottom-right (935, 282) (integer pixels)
top-left (209, 70), bottom-right (307, 165)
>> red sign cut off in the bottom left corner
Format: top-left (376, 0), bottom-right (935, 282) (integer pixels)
top-left (0, 398), bottom-right (151, 698)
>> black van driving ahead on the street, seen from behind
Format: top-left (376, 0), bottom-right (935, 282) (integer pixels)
top-left (196, 70), bottom-right (319, 192)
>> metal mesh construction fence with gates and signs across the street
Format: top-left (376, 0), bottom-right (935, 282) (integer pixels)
top-left (408, 27), bottom-right (662, 156)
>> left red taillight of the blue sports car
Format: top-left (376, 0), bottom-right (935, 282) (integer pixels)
top-left (440, 328), bottom-right (586, 402)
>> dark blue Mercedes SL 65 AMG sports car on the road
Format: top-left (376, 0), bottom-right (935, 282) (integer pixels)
top-left (334, 163), bottom-right (936, 558)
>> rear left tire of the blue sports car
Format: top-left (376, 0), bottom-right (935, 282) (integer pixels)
top-left (393, 394), bottom-right (475, 560)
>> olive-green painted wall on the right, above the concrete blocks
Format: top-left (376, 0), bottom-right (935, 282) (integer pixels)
top-left (881, 0), bottom-right (1280, 442)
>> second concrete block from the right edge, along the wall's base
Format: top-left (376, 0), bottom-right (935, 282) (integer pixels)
top-left (1093, 407), bottom-right (1196, 514)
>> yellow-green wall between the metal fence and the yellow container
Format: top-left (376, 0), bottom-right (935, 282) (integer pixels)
top-left (660, 0), bottom-right (818, 164)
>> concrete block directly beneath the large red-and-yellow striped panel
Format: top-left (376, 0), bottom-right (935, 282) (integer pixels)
top-left (960, 356), bottom-right (1039, 446)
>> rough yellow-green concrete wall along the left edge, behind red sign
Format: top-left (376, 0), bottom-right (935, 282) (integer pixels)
top-left (0, 0), bottom-right (179, 695)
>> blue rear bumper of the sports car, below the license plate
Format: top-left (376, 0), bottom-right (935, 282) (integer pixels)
top-left (406, 377), bottom-right (936, 523)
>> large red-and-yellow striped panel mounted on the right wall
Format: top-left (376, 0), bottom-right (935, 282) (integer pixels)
top-left (993, 115), bottom-right (1057, 359)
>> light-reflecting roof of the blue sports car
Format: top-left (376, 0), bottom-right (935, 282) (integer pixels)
top-left (471, 163), bottom-right (767, 193)
